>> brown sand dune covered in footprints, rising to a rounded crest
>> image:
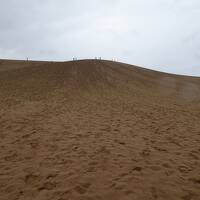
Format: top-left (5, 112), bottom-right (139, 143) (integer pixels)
top-left (0, 60), bottom-right (200, 200)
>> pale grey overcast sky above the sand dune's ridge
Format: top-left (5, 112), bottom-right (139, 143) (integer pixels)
top-left (0, 0), bottom-right (200, 76)
